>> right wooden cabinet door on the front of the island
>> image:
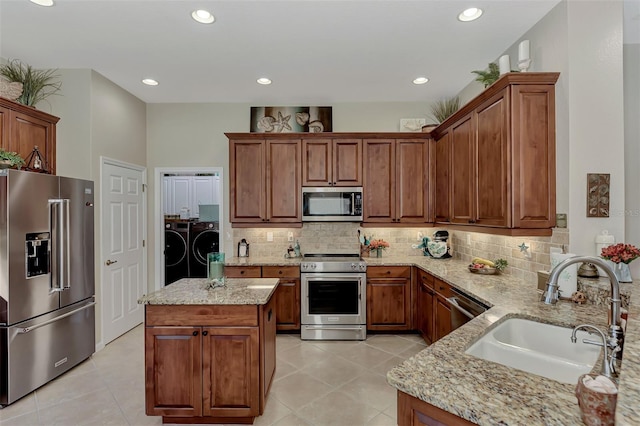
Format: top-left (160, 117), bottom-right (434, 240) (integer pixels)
top-left (202, 327), bottom-right (260, 417)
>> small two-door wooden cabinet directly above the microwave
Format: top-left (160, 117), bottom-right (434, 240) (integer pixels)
top-left (302, 138), bottom-right (362, 186)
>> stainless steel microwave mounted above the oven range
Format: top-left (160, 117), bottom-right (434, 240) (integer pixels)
top-left (302, 186), bottom-right (362, 222)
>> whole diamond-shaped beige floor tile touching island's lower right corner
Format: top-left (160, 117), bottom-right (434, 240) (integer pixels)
top-left (270, 371), bottom-right (333, 411)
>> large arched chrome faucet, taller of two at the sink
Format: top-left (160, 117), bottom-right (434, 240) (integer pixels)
top-left (542, 256), bottom-right (624, 357)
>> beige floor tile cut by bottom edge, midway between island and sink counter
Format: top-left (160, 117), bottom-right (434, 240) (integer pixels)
top-left (296, 391), bottom-right (380, 426)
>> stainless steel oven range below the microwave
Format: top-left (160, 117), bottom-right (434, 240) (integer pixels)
top-left (300, 254), bottom-right (367, 340)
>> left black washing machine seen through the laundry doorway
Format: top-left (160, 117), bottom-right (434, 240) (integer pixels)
top-left (164, 221), bottom-right (190, 285)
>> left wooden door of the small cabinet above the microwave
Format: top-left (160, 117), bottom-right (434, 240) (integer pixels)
top-left (302, 139), bottom-right (333, 186)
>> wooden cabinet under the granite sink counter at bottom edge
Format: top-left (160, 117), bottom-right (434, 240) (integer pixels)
top-left (398, 391), bottom-right (475, 426)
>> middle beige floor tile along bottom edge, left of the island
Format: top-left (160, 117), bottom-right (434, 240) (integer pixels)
top-left (40, 389), bottom-right (127, 426)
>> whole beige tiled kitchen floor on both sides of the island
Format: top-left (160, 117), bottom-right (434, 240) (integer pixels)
top-left (0, 326), bottom-right (425, 426)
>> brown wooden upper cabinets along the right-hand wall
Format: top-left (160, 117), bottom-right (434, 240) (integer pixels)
top-left (431, 73), bottom-right (559, 235)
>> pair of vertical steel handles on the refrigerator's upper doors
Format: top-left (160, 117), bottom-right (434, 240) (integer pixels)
top-left (49, 199), bottom-right (71, 292)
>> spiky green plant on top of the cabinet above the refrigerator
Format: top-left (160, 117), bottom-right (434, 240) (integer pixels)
top-left (0, 59), bottom-right (62, 106)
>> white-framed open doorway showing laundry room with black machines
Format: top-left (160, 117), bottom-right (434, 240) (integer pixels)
top-left (154, 167), bottom-right (224, 290)
